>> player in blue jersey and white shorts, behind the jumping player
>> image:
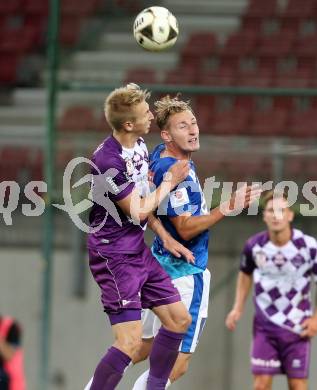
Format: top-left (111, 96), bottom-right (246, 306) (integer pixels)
top-left (133, 95), bottom-right (261, 390)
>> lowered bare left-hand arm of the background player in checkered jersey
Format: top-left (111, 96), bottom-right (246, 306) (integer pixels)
top-left (226, 271), bottom-right (252, 331)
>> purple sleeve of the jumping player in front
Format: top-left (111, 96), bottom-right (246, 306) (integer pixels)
top-left (94, 152), bottom-right (135, 202)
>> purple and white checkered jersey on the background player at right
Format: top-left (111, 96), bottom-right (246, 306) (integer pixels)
top-left (240, 229), bottom-right (317, 333)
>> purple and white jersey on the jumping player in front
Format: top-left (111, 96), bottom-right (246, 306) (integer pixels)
top-left (88, 136), bottom-right (148, 254)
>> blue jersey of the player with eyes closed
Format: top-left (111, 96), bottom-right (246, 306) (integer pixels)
top-left (150, 144), bottom-right (209, 279)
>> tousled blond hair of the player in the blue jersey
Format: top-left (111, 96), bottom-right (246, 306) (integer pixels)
top-left (154, 94), bottom-right (193, 130)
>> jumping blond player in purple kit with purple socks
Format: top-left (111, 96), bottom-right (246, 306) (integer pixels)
top-left (88, 84), bottom-right (191, 390)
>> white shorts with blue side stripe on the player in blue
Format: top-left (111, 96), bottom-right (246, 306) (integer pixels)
top-left (142, 269), bottom-right (210, 353)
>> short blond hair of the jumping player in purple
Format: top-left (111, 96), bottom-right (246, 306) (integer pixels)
top-left (104, 83), bottom-right (150, 130)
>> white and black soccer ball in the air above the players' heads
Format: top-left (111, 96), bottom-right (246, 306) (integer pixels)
top-left (133, 7), bottom-right (178, 51)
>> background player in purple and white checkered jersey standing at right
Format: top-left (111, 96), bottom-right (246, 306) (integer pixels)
top-left (226, 192), bottom-right (317, 390)
